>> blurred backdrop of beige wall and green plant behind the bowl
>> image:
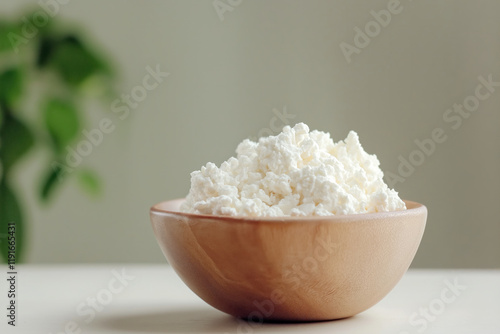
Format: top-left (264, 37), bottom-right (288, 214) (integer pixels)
top-left (0, 0), bottom-right (500, 268)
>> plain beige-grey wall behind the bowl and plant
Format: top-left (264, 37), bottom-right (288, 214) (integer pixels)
top-left (0, 0), bottom-right (500, 268)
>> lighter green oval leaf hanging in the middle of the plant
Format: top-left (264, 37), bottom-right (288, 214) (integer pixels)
top-left (42, 98), bottom-right (80, 153)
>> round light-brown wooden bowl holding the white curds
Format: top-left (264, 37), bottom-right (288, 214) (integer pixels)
top-left (150, 199), bottom-right (427, 322)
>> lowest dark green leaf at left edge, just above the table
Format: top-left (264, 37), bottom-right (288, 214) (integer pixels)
top-left (0, 179), bottom-right (24, 263)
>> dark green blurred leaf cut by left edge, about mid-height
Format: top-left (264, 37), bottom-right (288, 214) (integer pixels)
top-left (0, 112), bottom-right (35, 174)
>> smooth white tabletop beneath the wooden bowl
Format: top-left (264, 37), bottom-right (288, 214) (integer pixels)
top-left (0, 264), bottom-right (500, 334)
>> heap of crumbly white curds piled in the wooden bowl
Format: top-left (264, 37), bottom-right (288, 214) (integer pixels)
top-left (181, 123), bottom-right (406, 217)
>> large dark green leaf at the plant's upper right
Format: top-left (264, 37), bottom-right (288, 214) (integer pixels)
top-left (49, 36), bottom-right (107, 86)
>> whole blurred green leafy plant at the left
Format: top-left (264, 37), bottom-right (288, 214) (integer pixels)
top-left (0, 9), bottom-right (114, 262)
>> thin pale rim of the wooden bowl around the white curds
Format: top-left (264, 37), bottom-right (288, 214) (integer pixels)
top-left (149, 198), bottom-right (427, 223)
